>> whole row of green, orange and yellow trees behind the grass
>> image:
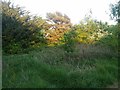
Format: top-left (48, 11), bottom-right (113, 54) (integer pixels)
top-left (0, 1), bottom-right (120, 54)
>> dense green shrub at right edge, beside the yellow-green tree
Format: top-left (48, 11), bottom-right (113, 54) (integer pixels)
top-left (96, 25), bottom-right (120, 51)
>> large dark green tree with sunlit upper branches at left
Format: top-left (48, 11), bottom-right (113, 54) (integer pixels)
top-left (0, 1), bottom-right (45, 54)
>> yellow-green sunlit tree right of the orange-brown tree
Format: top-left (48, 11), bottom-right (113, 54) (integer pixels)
top-left (74, 17), bottom-right (107, 44)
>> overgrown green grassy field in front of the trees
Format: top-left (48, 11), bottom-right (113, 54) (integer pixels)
top-left (3, 46), bottom-right (118, 88)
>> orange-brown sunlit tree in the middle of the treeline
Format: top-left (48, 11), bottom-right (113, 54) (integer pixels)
top-left (45, 12), bottom-right (72, 43)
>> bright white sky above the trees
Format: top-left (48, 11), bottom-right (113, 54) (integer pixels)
top-left (11, 0), bottom-right (118, 24)
